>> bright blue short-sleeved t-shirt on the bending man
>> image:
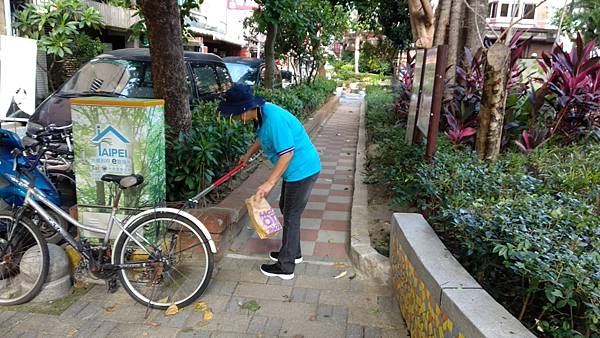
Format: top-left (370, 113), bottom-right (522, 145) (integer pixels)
top-left (256, 103), bottom-right (321, 182)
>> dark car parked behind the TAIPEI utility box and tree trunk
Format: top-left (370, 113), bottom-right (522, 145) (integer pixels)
top-left (27, 48), bottom-right (232, 133)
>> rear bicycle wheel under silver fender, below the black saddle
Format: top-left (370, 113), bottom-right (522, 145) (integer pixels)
top-left (114, 211), bottom-right (213, 309)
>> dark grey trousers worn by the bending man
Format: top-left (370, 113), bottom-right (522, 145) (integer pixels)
top-left (279, 173), bottom-right (319, 273)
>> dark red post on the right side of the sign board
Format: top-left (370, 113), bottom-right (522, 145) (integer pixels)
top-left (425, 45), bottom-right (448, 162)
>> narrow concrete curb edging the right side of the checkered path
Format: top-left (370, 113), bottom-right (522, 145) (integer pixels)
top-left (350, 96), bottom-right (390, 284)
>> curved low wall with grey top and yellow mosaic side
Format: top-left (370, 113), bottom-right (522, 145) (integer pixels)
top-left (390, 213), bottom-right (535, 338)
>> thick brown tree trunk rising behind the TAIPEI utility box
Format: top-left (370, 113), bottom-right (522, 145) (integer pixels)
top-left (138, 0), bottom-right (192, 131)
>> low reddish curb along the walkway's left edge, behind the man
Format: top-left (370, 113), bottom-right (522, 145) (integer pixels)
top-left (189, 95), bottom-right (340, 260)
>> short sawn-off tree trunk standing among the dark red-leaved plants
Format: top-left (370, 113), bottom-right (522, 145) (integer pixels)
top-left (475, 43), bottom-right (510, 161)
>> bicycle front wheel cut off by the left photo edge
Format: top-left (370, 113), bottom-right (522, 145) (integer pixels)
top-left (0, 212), bottom-right (49, 305)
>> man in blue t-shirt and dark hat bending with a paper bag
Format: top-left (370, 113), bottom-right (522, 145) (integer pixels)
top-left (219, 84), bottom-right (321, 279)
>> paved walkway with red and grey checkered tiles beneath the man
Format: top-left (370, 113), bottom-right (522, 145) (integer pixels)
top-left (0, 95), bottom-right (407, 338)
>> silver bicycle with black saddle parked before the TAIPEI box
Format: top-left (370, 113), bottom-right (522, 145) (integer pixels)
top-left (0, 149), bottom-right (217, 309)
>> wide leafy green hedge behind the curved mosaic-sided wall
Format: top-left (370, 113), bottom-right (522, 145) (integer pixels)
top-left (367, 87), bottom-right (600, 337)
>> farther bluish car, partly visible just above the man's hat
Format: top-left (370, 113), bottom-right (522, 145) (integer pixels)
top-left (223, 56), bottom-right (282, 88)
